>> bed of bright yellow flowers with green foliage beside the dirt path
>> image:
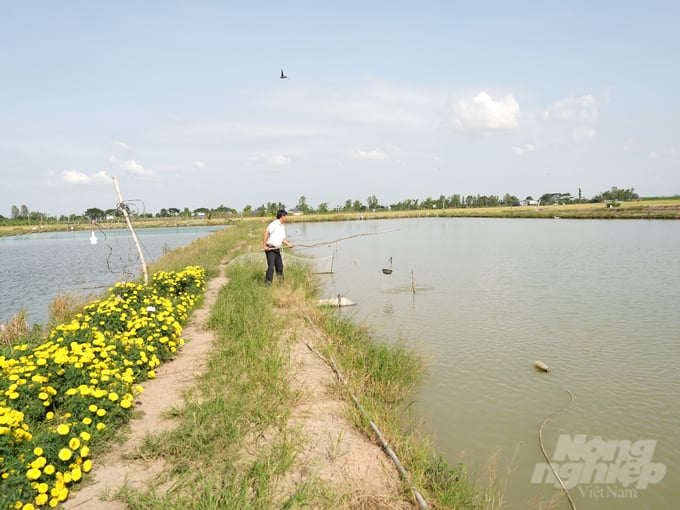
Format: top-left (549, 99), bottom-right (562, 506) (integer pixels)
top-left (0, 266), bottom-right (205, 510)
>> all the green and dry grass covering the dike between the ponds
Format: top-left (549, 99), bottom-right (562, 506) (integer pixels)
top-left (3, 222), bottom-right (502, 510)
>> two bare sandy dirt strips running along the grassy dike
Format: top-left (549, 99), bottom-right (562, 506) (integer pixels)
top-left (64, 262), bottom-right (414, 510)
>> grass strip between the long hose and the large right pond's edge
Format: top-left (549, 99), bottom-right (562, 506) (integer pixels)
top-left (314, 313), bottom-right (502, 509)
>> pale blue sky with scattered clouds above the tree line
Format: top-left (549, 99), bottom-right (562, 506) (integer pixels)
top-left (0, 0), bottom-right (680, 217)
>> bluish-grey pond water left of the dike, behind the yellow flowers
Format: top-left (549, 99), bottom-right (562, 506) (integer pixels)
top-left (0, 227), bottom-right (223, 324)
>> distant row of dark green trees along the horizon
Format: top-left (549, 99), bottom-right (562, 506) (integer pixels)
top-left (0, 186), bottom-right (640, 224)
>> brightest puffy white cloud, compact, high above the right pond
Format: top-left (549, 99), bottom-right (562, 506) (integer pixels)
top-left (451, 91), bottom-right (519, 136)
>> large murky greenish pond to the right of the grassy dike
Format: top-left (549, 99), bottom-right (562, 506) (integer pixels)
top-left (287, 218), bottom-right (680, 510)
